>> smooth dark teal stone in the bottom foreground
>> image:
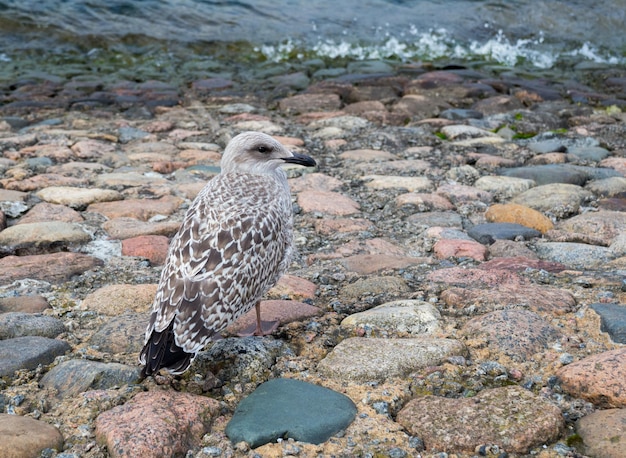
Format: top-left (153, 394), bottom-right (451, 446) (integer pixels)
top-left (225, 379), bottom-right (357, 448)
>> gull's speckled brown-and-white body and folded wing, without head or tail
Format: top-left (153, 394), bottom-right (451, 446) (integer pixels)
top-left (146, 174), bottom-right (291, 353)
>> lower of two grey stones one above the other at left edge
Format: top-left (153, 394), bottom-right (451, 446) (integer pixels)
top-left (0, 336), bottom-right (71, 377)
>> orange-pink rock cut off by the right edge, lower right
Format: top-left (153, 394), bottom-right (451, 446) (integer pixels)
top-left (557, 347), bottom-right (626, 408)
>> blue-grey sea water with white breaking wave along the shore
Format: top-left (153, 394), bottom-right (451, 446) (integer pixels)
top-left (0, 0), bottom-right (626, 82)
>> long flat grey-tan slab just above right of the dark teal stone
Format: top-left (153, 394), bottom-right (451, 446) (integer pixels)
top-left (317, 337), bottom-right (467, 382)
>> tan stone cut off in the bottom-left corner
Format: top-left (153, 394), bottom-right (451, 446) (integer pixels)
top-left (0, 413), bottom-right (63, 458)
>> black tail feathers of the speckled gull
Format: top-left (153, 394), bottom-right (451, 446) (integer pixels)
top-left (139, 320), bottom-right (196, 377)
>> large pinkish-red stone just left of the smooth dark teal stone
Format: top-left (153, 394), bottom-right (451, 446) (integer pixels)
top-left (95, 390), bottom-right (219, 458)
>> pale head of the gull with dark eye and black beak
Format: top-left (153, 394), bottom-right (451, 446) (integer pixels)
top-left (220, 132), bottom-right (316, 173)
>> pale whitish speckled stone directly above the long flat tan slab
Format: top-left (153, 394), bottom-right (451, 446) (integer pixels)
top-left (341, 300), bottom-right (441, 335)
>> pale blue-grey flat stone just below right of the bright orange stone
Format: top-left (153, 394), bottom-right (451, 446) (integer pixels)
top-left (535, 242), bottom-right (615, 269)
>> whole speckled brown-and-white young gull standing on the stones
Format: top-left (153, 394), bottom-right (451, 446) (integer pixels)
top-left (139, 132), bottom-right (315, 376)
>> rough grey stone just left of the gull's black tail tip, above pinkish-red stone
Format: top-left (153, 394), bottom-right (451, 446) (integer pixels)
top-left (39, 359), bottom-right (141, 398)
